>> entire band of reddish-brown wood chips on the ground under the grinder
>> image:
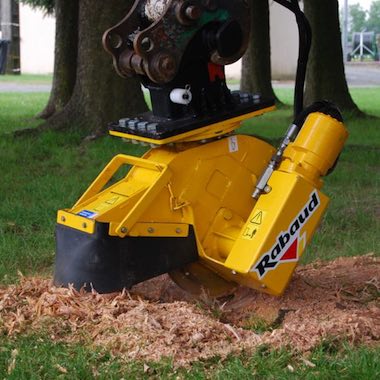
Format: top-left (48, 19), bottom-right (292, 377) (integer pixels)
top-left (0, 255), bottom-right (380, 366)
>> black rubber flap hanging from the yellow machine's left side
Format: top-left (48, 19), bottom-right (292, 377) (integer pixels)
top-left (54, 223), bottom-right (198, 293)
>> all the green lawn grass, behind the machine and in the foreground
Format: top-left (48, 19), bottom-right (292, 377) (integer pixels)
top-left (0, 88), bottom-right (380, 379)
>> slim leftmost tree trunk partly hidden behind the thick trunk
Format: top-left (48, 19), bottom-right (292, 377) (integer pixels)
top-left (38, 0), bottom-right (79, 119)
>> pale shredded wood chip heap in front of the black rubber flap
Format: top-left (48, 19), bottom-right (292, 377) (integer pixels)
top-left (0, 278), bottom-right (259, 365)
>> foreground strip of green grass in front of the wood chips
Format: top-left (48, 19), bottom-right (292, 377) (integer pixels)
top-left (0, 335), bottom-right (380, 380)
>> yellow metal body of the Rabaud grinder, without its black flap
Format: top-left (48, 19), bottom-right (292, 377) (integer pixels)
top-left (57, 113), bottom-right (348, 295)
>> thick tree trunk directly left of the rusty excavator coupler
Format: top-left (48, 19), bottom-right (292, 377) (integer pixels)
top-left (45, 0), bottom-right (147, 131)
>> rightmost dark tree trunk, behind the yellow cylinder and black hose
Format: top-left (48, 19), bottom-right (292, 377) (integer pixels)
top-left (304, 0), bottom-right (360, 114)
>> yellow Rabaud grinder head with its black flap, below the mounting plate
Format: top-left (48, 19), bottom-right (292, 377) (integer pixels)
top-left (55, 112), bottom-right (348, 295)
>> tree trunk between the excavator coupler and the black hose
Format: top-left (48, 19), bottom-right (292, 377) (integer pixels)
top-left (240, 0), bottom-right (278, 102)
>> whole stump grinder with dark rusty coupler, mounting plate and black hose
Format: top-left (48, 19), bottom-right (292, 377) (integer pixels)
top-left (54, 0), bottom-right (348, 296)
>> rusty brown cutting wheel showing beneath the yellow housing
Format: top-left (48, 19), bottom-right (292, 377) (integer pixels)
top-left (169, 262), bottom-right (237, 297)
